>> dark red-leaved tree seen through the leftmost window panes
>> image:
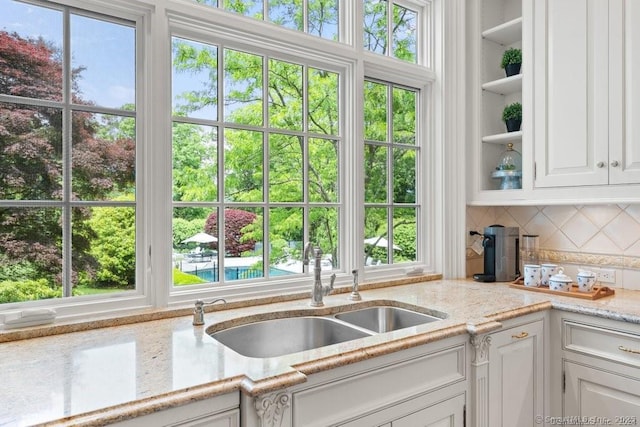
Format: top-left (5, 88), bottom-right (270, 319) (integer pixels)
top-left (0, 31), bottom-right (135, 290)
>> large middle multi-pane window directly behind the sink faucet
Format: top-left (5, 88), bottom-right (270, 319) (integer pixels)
top-left (172, 37), bottom-right (342, 287)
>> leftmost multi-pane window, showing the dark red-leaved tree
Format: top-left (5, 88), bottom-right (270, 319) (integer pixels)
top-left (0, 0), bottom-right (138, 304)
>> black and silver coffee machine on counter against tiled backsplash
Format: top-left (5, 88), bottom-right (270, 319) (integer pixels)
top-left (471, 224), bottom-right (520, 282)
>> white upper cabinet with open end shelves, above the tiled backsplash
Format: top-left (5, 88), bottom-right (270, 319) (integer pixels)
top-left (467, 0), bottom-right (640, 204)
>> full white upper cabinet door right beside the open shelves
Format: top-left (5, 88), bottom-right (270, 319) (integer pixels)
top-left (534, 0), bottom-right (609, 187)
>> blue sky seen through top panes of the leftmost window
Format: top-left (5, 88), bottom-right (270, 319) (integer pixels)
top-left (0, 0), bottom-right (135, 108)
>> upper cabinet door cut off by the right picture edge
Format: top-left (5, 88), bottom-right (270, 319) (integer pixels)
top-left (609, 0), bottom-right (640, 184)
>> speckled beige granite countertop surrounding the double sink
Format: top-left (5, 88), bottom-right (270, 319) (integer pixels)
top-left (0, 280), bottom-right (640, 426)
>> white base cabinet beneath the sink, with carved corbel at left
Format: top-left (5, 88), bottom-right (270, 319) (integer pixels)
top-left (241, 336), bottom-right (467, 427)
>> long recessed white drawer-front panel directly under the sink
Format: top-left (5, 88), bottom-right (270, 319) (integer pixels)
top-left (292, 345), bottom-right (466, 427)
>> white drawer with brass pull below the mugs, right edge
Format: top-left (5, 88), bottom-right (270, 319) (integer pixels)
top-left (562, 320), bottom-right (640, 367)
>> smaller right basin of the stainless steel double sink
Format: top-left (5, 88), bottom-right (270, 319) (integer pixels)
top-left (335, 306), bottom-right (441, 333)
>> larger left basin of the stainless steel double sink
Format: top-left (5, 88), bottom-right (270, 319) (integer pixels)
top-left (210, 317), bottom-right (373, 357)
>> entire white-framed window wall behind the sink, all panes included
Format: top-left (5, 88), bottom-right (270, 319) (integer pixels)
top-left (0, 0), bottom-right (436, 316)
